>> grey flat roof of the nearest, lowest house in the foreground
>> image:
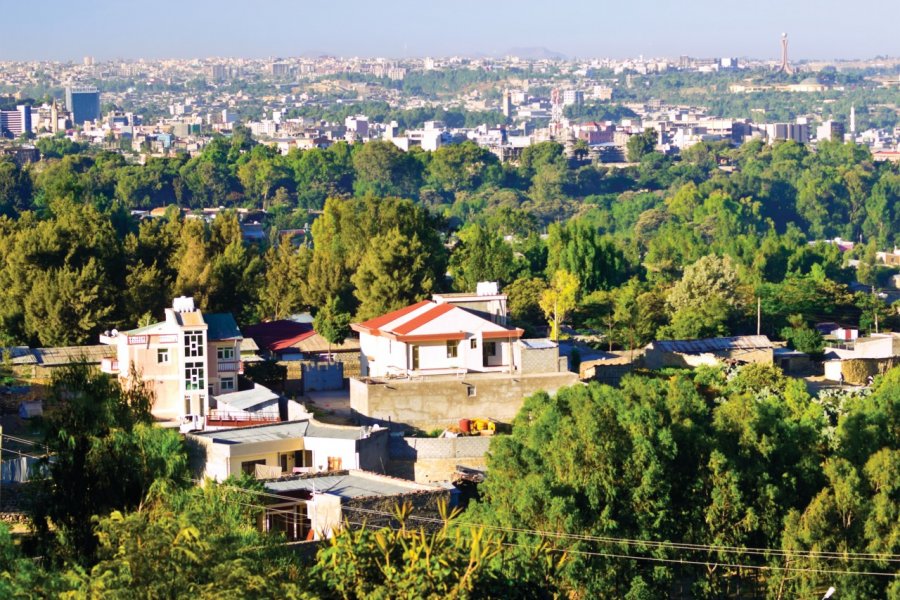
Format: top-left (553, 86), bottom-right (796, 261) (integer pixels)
top-left (265, 471), bottom-right (443, 498)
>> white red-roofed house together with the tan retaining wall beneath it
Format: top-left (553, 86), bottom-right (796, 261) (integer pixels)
top-left (350, 284), bottom-right (577, 428)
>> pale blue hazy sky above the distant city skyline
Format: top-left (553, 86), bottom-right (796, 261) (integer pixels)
top-left (0, 0), bottom-right (900, 60)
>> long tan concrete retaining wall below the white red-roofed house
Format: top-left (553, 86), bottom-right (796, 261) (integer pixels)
top-left (350, 373), bottom-right (578, 429)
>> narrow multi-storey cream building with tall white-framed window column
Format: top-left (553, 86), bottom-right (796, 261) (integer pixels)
top-left (100, 296), bottom-right (243, 420)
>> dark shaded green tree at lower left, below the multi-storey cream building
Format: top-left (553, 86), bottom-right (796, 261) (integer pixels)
top-left (32, 366), bottom-right (187, 561)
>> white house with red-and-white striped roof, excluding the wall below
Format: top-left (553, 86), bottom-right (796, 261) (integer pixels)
top-left (351, 294), bottom-right (523, 378)
